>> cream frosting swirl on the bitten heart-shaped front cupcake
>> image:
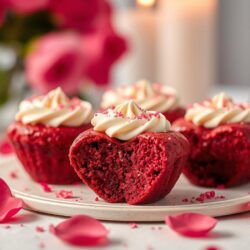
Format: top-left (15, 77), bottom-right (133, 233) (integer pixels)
top-left (91, 100), bottom-right (170, 141)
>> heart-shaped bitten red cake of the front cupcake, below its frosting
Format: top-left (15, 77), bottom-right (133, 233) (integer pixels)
top-left (69, 129), bottom-right (189, 204)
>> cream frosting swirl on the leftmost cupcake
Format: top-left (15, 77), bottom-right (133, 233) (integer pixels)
top-left (15, 88), bottom-right (93, 127)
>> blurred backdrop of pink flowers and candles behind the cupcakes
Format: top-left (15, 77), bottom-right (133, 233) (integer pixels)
top-left (0, 0), bottom-right (250, 129)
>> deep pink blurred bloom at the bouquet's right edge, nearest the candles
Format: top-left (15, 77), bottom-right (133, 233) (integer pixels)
top-left (83, 28), bottom-right (127, 84)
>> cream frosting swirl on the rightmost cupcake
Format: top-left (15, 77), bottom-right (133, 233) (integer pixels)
top-left (185, 93), bottom-right (250, 128)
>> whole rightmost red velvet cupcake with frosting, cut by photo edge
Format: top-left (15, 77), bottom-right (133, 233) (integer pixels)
top-left (173, 93), bottom-right (250, 187)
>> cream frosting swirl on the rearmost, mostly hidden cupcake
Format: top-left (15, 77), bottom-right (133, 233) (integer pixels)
top-left (101, 80), bottom-right (180, 112)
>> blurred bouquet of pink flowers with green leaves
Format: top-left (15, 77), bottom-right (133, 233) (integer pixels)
top-left (0, 0), bottom-right (128, 129)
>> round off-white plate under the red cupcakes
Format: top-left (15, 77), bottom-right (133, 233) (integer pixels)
top-left (0, 156), bottom-right (250, 221)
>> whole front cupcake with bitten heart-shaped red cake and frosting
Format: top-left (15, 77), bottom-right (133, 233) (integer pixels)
top-left (69, 100), bottom-right (189, 204)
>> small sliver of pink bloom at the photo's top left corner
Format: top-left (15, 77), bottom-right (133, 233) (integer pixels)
top-left (5, 0), bottom-right (50, 15)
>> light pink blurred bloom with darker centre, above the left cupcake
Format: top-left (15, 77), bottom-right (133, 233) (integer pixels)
top-left (26, 33), bottom-right (84, 94)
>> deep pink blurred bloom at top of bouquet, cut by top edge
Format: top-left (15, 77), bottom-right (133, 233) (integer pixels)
top-left (50, 0), bottom-right (111, 32)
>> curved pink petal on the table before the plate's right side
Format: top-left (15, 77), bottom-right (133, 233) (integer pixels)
top-left (165, 213), bottom-right (217, 237)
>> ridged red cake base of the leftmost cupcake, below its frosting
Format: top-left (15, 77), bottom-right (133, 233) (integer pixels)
top-left (8, 122), bottom-right (91, 184)
